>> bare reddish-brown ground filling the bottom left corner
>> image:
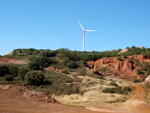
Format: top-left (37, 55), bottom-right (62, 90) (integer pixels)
top-left (0, 86), bottom-right (105, 113)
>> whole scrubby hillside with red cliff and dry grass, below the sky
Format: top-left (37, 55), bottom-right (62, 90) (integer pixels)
top-left (0, 47), bottom-right (150, 112)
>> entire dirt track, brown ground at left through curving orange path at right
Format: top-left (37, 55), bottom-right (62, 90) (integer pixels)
top-left (0, 84), bottom-right (150, 113)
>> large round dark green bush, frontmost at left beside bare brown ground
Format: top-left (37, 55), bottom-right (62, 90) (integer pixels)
top-left (25, 71), bottom-right (45, 85)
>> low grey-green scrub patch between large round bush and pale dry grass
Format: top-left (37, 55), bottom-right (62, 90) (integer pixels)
top-left (39, 72), bottom-right (76, 95)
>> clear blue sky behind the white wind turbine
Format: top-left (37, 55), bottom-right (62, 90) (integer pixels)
top-left (0, 0), bottom-right (150, 55)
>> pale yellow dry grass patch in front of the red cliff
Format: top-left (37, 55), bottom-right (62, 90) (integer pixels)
top-left (53, 76), bottom-right (130, 106)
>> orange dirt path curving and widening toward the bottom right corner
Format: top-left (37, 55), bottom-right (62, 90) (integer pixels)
top-left (86, 84), bottom-right (150, 113)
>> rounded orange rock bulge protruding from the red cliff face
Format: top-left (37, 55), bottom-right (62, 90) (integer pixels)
top-left (122, 60), bottom-right (133, 73)
